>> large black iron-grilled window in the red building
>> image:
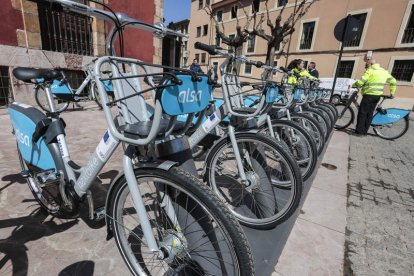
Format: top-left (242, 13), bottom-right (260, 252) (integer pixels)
top-left (38, 1), bottom-right (93, 56)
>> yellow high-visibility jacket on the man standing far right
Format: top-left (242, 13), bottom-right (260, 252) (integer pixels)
top-left (352, 63), bottom-right (397, 96)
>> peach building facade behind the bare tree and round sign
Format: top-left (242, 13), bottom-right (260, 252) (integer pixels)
top-left (189, 0), bottom-right (414, 99)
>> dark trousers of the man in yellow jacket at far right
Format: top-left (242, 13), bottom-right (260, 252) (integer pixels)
top-left (355, 95), bottom-right (381, 134)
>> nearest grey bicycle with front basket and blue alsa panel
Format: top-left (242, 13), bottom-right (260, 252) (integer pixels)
top-left (9, 0), bottom-right (254, 275)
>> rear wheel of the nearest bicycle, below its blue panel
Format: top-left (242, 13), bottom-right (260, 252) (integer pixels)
top-left (17, 144), bottom-right (80, 219)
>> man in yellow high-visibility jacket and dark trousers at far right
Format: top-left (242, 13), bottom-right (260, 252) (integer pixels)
top-left (352, 59), bottom-right (397, 135)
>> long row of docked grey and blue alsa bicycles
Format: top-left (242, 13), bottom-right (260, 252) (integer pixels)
top-left (4, 0), bottom-right (368, 275)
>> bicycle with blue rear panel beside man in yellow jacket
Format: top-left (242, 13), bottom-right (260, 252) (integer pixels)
top-left (335, 89), bottom-right (410, 140)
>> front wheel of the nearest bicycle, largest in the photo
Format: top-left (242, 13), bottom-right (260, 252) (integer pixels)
top-left (107, 167), bottom-right (254, 276)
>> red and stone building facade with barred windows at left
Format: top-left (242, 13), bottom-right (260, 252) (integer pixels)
top-left (0, 0), bottom-right (164, 108)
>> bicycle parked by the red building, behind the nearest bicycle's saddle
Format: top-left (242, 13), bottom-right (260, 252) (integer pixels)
top-left (35, 65), bottom-right (114, 112)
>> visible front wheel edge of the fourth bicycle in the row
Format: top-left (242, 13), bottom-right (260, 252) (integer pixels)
top-left (290, 113), bottom-right (325, 155)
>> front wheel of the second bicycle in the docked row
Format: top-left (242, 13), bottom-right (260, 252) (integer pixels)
top-left (205, 132), bottom-right (303, 229)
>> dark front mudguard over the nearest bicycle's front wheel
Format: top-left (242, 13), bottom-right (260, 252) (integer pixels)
top-left (105, 160), bottom-right (179, 240)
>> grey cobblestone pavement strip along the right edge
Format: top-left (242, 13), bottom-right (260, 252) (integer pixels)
top-left (344, 117), bottom-right (414, 275)
